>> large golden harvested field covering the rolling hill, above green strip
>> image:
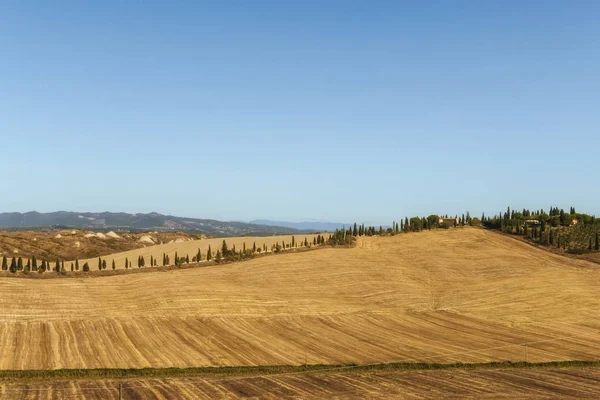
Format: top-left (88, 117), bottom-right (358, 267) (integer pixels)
top-left (0, 228), bottom-right (600, 370)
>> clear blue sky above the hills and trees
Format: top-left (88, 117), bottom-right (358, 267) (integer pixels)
top-left (0, 0), bottom-right (600, 223)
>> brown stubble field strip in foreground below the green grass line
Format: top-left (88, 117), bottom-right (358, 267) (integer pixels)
top-left (0, 368), bottom-right (600, 400)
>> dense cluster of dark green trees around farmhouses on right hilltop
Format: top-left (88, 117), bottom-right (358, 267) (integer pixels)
top-left (482, 207), bottom-right (600, 252)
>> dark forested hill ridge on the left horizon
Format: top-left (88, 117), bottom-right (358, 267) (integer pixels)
top-left (0, 211), bottom-right (312, 236)
